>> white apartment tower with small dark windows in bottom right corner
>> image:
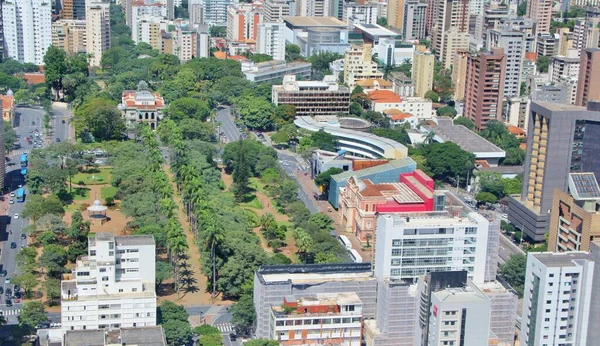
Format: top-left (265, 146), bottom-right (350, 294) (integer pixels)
top-left (520, 251), bottom-right (598, 346)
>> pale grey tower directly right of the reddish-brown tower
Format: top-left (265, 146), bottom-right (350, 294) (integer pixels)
top-left (486, 29), bottom-right (525, 98)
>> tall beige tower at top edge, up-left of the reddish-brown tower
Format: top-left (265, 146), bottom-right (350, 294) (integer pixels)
top-left (431, 0), bottom-right (469, 68)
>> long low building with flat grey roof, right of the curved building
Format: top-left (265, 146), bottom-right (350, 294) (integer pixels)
top-left (423, 117), bottom-right (506, 158)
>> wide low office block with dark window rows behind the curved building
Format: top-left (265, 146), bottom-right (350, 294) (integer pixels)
top-left (271, 75), bottom-right (350, 117)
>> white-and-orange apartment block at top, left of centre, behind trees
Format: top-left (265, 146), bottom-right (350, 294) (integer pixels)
top-left (227, 4), bottom-right (263, 42)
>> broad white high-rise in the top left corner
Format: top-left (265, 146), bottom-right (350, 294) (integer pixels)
top-left (2, 0), bottom-right (52, 65)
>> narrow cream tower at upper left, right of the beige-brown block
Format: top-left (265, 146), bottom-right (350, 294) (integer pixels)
top-left (85, 3), bottom-right (110, 66)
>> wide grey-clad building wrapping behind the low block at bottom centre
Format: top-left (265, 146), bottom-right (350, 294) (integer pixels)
top-left (254, 263), bottom-right (377, 338)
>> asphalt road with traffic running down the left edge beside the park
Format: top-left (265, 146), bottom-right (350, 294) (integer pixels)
top-left (0, 104), bottom-right (69, 324)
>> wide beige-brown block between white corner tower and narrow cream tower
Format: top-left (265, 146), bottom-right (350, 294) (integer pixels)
top-left (52, 20), bottom-right (87, 54)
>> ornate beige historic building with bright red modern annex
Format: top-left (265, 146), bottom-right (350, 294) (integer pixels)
top-left (338, 170), bottom-right (446, 246)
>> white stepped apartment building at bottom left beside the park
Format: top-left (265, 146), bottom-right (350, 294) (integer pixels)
top-left (61, 233), bottom-right (156, 333)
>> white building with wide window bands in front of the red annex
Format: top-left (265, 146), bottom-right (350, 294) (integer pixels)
top-left (373, 212), bottom-right (489, 284)
